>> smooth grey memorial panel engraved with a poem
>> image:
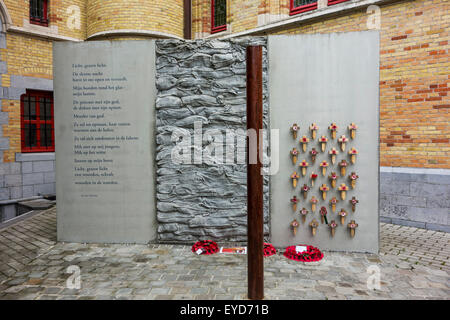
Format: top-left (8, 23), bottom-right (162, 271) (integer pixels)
top-left (54, 41), bottom-right (156, 243)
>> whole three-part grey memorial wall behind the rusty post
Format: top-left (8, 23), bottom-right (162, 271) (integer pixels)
top-left (54, 32), bottom-right (379, 252)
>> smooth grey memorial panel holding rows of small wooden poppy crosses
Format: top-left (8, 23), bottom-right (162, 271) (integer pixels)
top-left (268, 31), bottom-right (380, 252)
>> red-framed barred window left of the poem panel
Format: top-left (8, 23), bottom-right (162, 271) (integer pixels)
top-left (20, 90), bottom-right (55, 152)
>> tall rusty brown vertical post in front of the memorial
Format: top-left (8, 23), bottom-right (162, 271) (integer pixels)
top-left (247, 46), bottom-right (264, 300)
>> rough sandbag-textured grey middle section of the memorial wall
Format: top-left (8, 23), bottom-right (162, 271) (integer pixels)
top-left (156, 38), bottom-right (269, 242)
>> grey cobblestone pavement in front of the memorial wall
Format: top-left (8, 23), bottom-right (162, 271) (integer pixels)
top-left (0, 209), bottom-right (450, 300)
